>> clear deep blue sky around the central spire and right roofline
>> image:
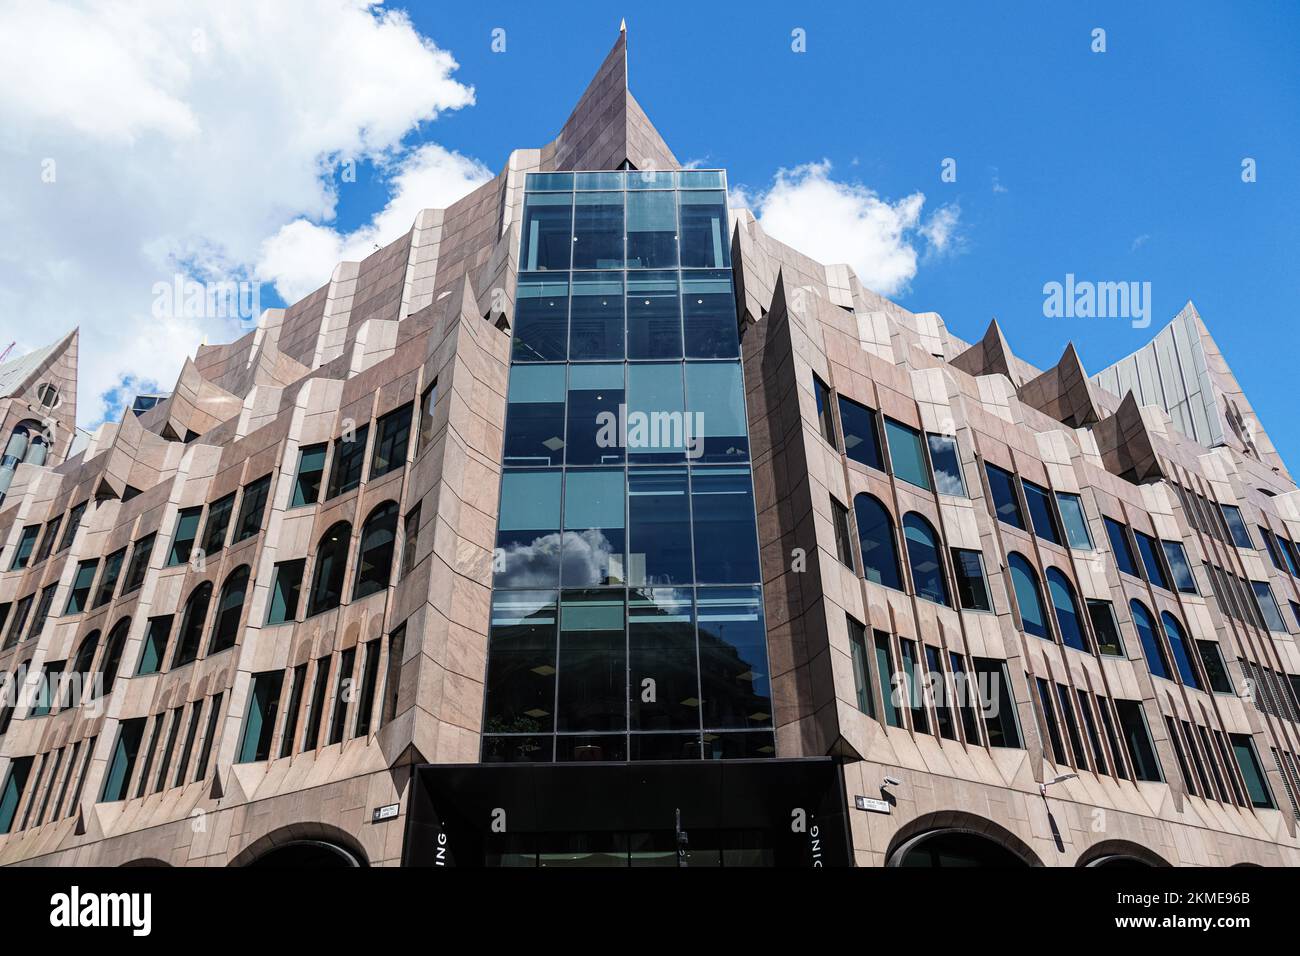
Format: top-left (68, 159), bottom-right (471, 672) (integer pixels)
top-left (337, 3), bottom-right (1300, 466)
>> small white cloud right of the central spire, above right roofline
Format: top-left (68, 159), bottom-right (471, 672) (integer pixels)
top-left (731, 160), bottom-right (961, 295)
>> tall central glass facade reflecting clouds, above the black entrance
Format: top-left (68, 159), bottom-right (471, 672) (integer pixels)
top-left (482, 170), bottom-right (775, 761)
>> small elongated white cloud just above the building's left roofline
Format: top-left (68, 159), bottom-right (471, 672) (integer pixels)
top-left (255, 143), bottom-right (491, 302)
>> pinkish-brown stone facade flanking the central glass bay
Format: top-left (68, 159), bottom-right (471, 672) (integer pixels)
top-left (0, 27), bottom-right (1300, 865)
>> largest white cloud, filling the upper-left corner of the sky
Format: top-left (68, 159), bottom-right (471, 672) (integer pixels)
top-left (0, 0), bottom-right (482, 424)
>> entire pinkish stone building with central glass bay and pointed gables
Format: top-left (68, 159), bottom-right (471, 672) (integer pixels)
top-left (0, 27), bottom-right (1300, 866)
